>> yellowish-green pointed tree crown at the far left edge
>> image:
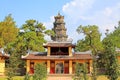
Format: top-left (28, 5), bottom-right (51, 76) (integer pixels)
top-left (0, 14), bottom-right (18, 48)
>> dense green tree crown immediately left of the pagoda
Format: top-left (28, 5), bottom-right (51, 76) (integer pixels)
top-left (17, 20), bottom-right (53, 52)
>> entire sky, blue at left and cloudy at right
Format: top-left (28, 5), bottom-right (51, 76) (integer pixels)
top-left (0, 0), bottom-right (120, 43)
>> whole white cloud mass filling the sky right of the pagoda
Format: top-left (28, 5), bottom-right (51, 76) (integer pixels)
top-left (62, 0), bottom-right (120, 40)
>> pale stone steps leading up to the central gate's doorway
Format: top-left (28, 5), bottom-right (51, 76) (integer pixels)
top-left (47, 74), bottom-right (73, 80)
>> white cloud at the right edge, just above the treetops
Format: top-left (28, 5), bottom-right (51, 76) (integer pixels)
top-left (89, 4), bottom-right (120, 32)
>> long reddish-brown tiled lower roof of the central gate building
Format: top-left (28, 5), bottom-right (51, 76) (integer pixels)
top-left (22, 53), bottom-right (92, 60)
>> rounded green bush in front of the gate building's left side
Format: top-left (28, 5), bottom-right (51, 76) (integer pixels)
top-left (33, 63), bottom-right (47, 80)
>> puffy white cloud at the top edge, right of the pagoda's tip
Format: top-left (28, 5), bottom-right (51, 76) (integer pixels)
top-left (62, 0), bottom-right (94, 16)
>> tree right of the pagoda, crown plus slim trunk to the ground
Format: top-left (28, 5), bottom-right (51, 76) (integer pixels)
top-left (77, 25), bottom-right (102, 80)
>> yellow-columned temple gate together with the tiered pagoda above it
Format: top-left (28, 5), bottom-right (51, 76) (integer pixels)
top-left (22, 13), bottom-right (92, 74)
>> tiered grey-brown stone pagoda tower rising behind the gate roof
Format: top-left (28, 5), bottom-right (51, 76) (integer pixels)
top-left (51, 13), bottom-right (68, 41)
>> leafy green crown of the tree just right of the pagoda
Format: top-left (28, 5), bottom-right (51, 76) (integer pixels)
top-left (75, 25), bottom-right (102, 51)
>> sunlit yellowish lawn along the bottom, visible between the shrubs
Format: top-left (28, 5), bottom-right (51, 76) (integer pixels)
top-left (0, 76), bottom-right (120, 80)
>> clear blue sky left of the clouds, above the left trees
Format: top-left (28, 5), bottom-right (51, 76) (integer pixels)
top-left (0, 0), bottom-right (70, 26)
